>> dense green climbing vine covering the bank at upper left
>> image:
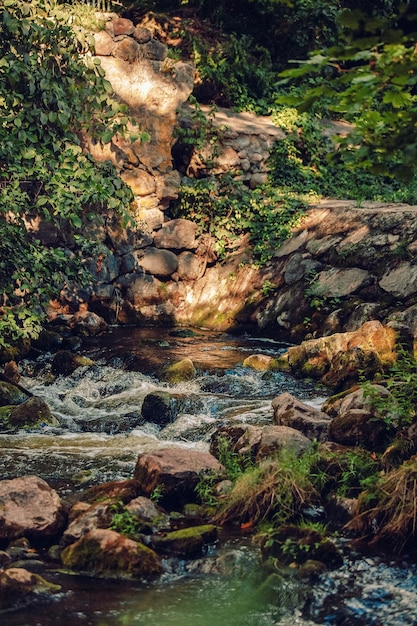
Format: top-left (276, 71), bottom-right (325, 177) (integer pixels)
top-left (0, 0), bottom-right (141, 346)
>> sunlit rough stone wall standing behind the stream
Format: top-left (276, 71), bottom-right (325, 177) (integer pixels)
top-left (45, 18), bottom-right (417, 348)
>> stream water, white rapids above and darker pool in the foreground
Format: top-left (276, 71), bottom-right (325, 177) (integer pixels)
top-left (0, 328), bottom-right (417, 626)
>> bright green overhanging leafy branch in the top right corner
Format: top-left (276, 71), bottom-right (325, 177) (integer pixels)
top-left (279, 2), bottom-right (417, 180)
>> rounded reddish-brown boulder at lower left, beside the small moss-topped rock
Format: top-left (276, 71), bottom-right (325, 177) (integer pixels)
top-left (61, 529), bottom-right (163, 580)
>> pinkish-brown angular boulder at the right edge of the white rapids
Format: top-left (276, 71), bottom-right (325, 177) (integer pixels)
top-left (272, 392), bottom-right (331, 441)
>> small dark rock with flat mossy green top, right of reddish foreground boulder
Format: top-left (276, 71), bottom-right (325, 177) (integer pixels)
top-left (152, 524), bottom-right (217, 557)
